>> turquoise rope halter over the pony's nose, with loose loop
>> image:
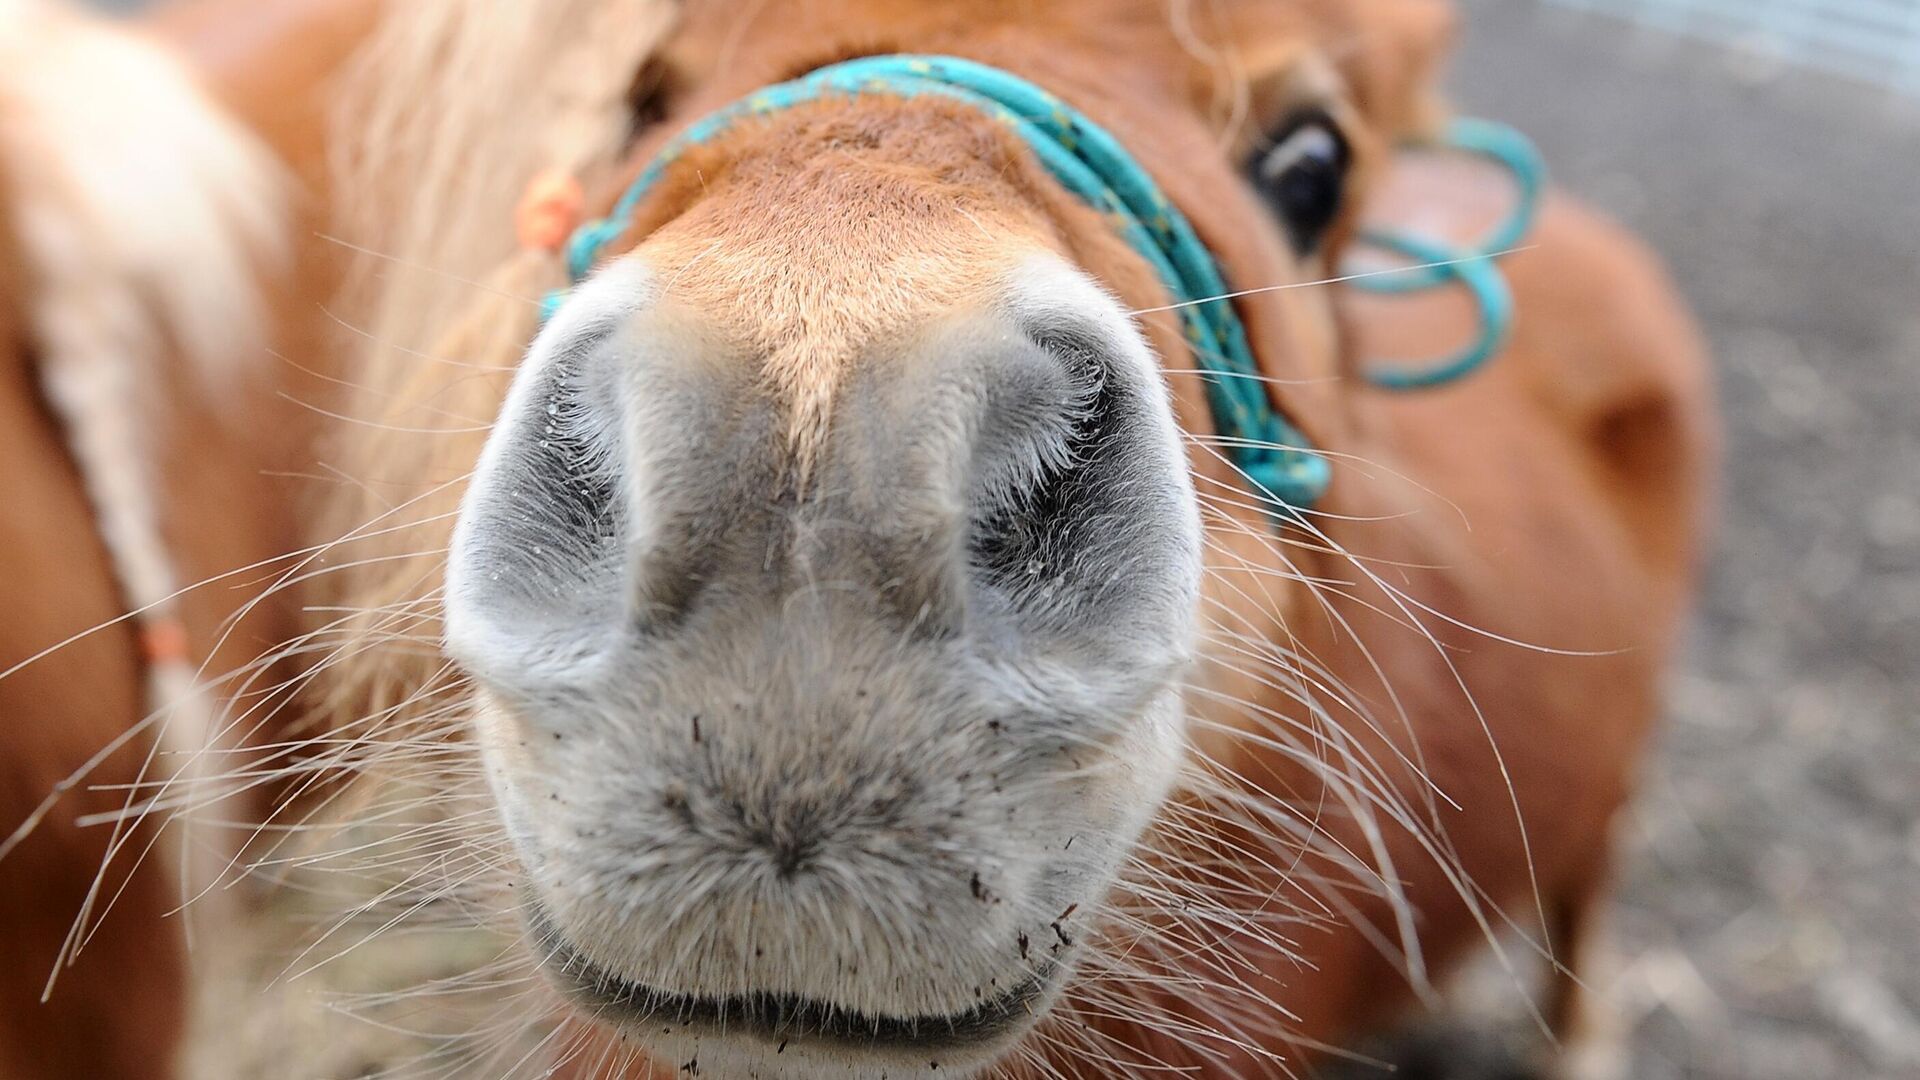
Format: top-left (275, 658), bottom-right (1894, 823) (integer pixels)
top-left (547, 56), bottom-right (1530, 515)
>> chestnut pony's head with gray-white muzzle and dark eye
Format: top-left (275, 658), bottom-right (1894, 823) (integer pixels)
top-left (353, 4), bottom-right (1451, 1076)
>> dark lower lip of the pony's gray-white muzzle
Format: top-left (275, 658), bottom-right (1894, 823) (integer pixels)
top-left (528, 909), bottom-right (1060, 1051)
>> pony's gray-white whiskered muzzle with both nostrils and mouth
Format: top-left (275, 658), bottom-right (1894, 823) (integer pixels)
top-left (447, 256), bottom-right (1200, 1076)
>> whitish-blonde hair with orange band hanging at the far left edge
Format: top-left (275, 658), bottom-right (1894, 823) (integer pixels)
top-left (0, 0), bottom-right (290, 907)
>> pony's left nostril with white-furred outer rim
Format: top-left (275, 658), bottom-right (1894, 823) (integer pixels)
top-left (447, 261), bottom-right (744, 686)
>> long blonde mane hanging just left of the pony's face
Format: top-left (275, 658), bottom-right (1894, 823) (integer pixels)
top-left (319, 0), bottom-right (678, 717)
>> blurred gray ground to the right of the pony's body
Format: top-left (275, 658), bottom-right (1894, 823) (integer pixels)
top-left (1452, 0), bottom-right (1920, 1080)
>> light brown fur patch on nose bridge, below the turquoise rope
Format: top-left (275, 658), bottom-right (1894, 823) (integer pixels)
top-left (637, 102), bottom-right (1041, 475)
